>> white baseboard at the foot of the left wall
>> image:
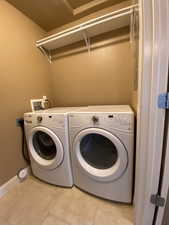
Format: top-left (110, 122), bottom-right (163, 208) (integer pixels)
top-left (0, 167), bottom-right (30, 198)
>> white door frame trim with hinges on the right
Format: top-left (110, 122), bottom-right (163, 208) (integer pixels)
top-left (135, 0), bottom-right (168, 225)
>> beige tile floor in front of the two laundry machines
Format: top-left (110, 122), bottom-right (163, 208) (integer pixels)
top-left (0, 177), bottom-right (133, 225)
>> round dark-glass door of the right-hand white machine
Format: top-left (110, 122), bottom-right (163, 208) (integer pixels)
top-left (73, 128), bottom-right (128, 182)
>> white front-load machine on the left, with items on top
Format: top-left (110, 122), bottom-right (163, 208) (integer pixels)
top-left (24, 107), bottom-right (84, 187)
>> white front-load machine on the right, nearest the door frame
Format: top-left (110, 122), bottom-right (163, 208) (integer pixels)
top-left (69, 105), bottom-right (134, 203)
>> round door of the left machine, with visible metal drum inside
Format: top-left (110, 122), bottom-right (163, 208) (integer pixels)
top-left (28, 127), bottom-right (64, 169)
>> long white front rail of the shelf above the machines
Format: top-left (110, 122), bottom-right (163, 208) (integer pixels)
top-left (36, 4), bottom-right (138, 47)
